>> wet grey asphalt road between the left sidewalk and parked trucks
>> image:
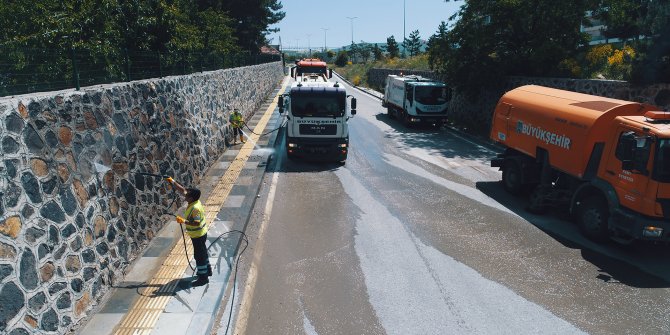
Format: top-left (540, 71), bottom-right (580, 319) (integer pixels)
top-left (219, 77), bottom-right (670, 335)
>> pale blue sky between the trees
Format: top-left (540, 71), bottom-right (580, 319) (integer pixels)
top-left (268, 0), bottom-right (463, 49)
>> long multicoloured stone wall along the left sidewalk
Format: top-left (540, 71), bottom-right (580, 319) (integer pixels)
top-left (0, 62), bottom-right (283, 334)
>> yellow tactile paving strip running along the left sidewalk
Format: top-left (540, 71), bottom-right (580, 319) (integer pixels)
top-left (114, 79), bottom-right (288, 335)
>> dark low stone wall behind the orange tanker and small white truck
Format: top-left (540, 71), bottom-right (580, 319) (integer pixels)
top-left (368, 69), bottom-right (670, 136)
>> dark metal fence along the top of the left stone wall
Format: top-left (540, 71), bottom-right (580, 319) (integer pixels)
top-left (0, 47), bottom-right (281, 96)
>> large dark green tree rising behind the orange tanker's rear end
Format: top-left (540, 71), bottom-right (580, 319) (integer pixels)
top-left (433, 0), bottom-right (593, 93)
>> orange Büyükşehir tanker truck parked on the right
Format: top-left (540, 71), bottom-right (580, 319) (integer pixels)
top-left (490, 85), bottom-right (670, 243)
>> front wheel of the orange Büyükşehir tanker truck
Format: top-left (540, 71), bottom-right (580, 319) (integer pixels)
top-left (577, 196), bottom-right (609, 242)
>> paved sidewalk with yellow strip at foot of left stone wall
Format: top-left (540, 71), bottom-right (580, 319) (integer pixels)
top-left (79, 81), bottom-right (286, 335)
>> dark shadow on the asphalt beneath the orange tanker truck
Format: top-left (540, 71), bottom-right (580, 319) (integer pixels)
top-left (476, 182), bottom-right (670, 288)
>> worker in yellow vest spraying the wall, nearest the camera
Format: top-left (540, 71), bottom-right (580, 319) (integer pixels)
top-left (167, 177), bottom-right (212, 287)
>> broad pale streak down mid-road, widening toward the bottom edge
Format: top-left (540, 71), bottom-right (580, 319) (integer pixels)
top-left (335, 169), bottom-right (582, 334)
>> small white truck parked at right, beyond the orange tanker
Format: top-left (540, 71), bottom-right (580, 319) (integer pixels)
top-left (382, 75), bottom-right (451, 126)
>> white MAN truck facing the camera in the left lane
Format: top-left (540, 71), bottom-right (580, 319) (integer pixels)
top-left (279, 76), bottom-right (356, 163)
